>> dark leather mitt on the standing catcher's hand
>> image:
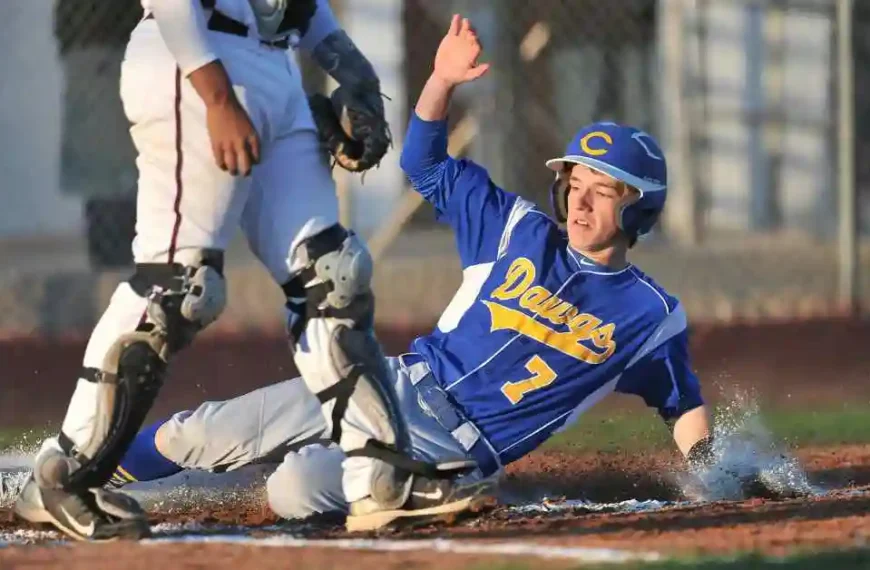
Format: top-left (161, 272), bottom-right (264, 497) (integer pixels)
top-left (308, 86), bottom-right (392, 172)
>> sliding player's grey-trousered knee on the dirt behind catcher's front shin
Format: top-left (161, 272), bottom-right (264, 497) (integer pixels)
top-left (266, 444), bottom-right (348, 520)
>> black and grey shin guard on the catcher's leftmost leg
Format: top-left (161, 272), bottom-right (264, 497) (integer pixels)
top-left (46, 250), bottom-right (226, 490)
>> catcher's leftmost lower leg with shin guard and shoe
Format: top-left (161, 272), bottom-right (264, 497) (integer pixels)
top-left (15, 250), bottom-right (226, 540)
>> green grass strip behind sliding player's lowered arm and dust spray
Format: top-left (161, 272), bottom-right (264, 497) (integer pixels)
top-left (546, 406), bottom-right (870, 452)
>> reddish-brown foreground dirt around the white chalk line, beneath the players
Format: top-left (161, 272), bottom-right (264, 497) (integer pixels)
top-left (0, 446), bottom-right (870, 570)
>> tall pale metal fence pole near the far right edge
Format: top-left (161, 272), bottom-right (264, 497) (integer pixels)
top-left (837, 0), bottom-right (858, 316)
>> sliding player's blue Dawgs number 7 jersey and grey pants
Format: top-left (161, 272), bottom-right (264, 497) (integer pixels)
top-left (115, 112), bottom-right (703, 517)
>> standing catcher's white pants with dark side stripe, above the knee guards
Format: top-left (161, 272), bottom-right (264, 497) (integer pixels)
top-left (124, 0), bottom-right (337, 280)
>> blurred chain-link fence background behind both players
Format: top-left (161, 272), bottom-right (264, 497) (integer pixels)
top-left (0, 0), bottom-right (870, 335)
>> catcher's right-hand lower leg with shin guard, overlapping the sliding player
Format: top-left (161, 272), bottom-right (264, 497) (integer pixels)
top-left (284, 218), bottom-right (474, 530)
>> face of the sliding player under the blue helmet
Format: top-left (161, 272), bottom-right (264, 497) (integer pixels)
top-left (568, 164), bottom-right (635, 251)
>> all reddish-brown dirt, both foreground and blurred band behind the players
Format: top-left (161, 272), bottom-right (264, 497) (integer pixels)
top-left (0, 321), bottom-right (870, 570)
